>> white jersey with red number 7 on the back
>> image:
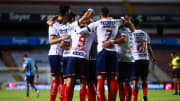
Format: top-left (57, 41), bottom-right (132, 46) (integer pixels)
top-left (80, 18), bottom-right (123, 52)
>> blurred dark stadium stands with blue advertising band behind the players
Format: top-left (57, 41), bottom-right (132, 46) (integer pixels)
top-left (0, 0), bottom-right (180, 88)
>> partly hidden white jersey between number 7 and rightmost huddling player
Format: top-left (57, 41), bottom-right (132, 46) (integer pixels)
top-left (118, 27), bottom-right (134, 62)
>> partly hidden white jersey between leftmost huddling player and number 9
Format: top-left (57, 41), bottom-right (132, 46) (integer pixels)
top-left (63, 21), bottom-right (79, 57)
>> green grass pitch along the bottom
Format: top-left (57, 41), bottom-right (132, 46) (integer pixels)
top-left (0, 90), bottom-right (180, 101)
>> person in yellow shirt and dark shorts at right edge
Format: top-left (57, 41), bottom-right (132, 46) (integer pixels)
top-left (170, 52), bottom-right (180, 95)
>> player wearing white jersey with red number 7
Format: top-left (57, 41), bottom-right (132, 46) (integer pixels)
top-left (79, 8), bottom-right (123, 101)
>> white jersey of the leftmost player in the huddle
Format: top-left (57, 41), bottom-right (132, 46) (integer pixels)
top-left (48, 21), bottom-right (67, 55)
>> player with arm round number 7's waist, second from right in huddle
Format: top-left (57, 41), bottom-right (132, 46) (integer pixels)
top-left (103, 22), bottom-right (133, 101)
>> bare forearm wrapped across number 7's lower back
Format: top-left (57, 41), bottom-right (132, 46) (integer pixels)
top-left (103, 36), bottom-right (126, 48)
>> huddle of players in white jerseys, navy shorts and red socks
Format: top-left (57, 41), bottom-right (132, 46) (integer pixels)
top-left (47, 6), bottom-right (155, 101)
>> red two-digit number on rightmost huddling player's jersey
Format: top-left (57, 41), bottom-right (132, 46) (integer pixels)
top-left (137, 40), bottom-right (147, 53)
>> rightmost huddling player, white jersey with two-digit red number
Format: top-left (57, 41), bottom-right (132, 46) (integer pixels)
top-left (132, 19), bottom-right (155, 101)
